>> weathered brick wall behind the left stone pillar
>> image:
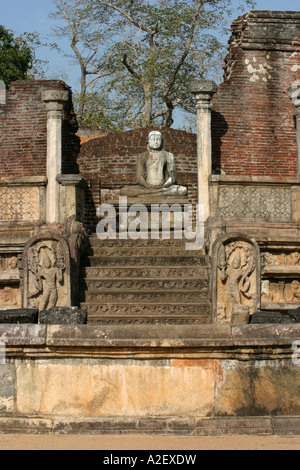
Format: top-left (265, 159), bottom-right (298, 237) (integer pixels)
top-left (0, 80), bottom-right (80, 177)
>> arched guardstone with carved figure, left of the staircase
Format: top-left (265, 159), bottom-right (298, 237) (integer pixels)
top-left (23, 233), bottom-right (71, 311)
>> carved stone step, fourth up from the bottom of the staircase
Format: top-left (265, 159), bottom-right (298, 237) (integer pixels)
top-left (82, 277), bottom-right (208, 292)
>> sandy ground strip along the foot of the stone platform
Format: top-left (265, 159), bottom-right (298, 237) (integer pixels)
top-left (0, 434), bottom-right (300, 454)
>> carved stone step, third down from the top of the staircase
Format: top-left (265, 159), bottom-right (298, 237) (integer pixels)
top-left (82, 254), bottom-right (207, 267)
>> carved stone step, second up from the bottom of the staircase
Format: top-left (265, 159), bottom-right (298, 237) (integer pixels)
top-left (81, 302), bottom-right (211, 320)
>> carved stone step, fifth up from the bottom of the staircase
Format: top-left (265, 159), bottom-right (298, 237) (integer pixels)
top-left (81, 265), bottom-right (208, 279)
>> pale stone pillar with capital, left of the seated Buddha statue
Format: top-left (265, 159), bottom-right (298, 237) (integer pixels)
top-left (42, 90), bottom-right (69, 224)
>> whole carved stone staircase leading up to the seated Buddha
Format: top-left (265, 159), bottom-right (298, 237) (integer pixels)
top-left (81, 235), bottom-right (211, 324)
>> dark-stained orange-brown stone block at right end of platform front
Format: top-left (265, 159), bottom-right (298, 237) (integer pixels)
top-left (215, 359), bottom-right (300, 416)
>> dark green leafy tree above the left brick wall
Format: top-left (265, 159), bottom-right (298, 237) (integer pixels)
top-left (0, 25), bottom-right (34, 86)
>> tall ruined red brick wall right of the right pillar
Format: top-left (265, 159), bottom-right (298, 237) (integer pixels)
top-left (213, 11), bottom-right (300, 176)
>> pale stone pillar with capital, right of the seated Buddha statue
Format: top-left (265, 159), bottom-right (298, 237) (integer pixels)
top-left (191, 80), bottom-right (218, 222)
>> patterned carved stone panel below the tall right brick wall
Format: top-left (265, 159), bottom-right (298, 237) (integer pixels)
top-left (218, 185), bottom-right (292, 222)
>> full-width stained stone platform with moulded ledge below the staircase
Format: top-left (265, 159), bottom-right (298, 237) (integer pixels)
top-left (0, 324), bottom-right (300, 436)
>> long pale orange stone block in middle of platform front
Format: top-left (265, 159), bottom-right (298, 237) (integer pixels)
top-left (16, 360), bottom-right (215, 418)
